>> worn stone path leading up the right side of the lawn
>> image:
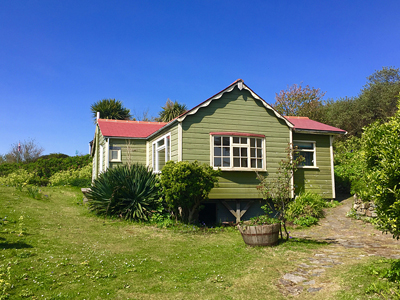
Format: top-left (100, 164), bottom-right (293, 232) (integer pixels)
top-left (278, 198), bottom-right (400, 296)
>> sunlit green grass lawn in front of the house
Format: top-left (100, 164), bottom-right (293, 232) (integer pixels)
top-left (0, 187), bottom-right (396, 299)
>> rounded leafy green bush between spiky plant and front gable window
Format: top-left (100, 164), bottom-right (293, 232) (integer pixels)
top-left (161, 161), bottom-right (221, 224)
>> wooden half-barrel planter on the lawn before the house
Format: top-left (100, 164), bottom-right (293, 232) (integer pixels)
top-left (238, 223), bottom-right (281, 247)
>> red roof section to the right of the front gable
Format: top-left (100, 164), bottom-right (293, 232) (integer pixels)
top-left (285, 116), bottom-right (347, 134)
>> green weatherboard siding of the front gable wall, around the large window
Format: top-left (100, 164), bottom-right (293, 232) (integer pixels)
top-left (182, 88), bottom-right (290, 199)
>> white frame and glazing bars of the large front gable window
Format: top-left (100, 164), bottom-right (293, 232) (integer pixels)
top-left (210, 134), bottom-right (267, 171)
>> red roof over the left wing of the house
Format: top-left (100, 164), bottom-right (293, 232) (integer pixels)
top-left (98, 119), bottom-right (167, 138)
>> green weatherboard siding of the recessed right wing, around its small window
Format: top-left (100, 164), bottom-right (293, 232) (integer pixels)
top-left (293, 133), bottom-right (333, 199)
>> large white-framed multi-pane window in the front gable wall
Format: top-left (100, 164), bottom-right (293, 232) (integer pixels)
top-left (211, 133), bottom-right (266, 170)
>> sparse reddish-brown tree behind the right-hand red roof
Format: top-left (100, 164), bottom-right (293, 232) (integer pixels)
top-left (274, 84), bottom-right (326, 121)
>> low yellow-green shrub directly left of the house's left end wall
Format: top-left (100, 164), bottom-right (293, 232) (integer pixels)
top-left (49, 163), bottom-right (92, 187)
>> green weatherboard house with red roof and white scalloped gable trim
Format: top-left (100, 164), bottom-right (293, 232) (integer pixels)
top-left (91, 79), bottom-right (346, 222)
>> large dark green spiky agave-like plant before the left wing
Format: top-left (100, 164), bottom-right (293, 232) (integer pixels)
top-left (86, 164), bottom-right (160, 220)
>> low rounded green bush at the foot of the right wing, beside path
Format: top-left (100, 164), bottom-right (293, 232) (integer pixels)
top-left (287, 192), bottom-right (327, 226)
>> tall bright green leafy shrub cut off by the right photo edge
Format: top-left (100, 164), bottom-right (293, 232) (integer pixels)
top-left (360, 101), bottom-right (400, 239)
